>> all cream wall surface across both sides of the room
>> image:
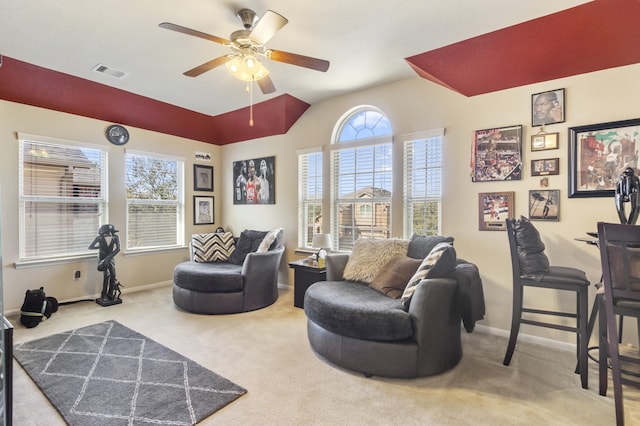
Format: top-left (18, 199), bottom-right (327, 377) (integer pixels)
top-left (0, 65), bottom-right (640, 342)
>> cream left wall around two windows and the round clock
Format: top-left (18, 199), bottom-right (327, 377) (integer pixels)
top-left (0, 101), bottom-right (222, 311)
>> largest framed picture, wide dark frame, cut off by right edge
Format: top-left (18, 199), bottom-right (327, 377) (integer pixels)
top-left (569, 118), bottom-right (640, 198)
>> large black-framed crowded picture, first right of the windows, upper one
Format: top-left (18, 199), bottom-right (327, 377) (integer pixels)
top-left (471, 125), bottom-right (522, 182)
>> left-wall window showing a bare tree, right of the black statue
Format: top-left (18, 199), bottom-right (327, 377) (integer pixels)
top-left (125, 152), bottom-right (184, 250)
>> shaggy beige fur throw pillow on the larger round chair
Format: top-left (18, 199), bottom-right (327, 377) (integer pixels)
top-left (342, 238), bottom-right (409, 284)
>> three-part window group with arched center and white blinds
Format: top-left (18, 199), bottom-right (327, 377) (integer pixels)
top-left (298, 106), bottom-right (444, 251)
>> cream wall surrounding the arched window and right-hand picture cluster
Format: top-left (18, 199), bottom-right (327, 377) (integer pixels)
top-left (222, 65), bottom-right (640, 342)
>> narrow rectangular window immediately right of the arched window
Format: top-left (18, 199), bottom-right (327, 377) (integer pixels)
top-left (403, 130), bottom-right (444, 238)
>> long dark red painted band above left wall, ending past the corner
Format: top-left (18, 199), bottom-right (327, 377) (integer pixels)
top-left (0, 56), bottom-right (309, 145)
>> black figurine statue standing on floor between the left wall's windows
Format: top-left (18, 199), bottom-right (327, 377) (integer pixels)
top-left (89, 224), bottom-right (122, 306)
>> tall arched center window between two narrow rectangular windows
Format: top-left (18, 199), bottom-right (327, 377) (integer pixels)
top-left (331, 107), bottom-right (393, 250)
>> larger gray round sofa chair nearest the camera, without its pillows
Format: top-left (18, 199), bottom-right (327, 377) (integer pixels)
top-left (304, 235), bottom-right (485, 378)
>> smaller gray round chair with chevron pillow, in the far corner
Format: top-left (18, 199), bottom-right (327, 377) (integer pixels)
top-left (173, 228), bottom-right (284, 314)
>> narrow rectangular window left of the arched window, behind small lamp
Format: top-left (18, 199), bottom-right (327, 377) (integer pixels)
top-left (298, 151), bottom-right (323, 248)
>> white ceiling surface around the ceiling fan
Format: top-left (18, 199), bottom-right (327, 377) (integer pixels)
top-left (0, 0), bottom-right (587, 115)
